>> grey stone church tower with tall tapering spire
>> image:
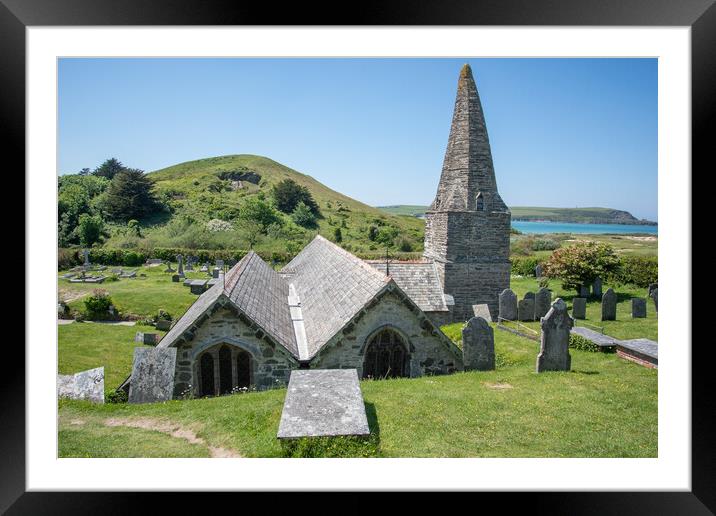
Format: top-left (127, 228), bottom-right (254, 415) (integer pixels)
top-left (424, 64), bottom-right (511, 321)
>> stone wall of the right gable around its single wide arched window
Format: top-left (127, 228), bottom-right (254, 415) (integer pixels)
top-left (310, 288), bottom-right (463, 377)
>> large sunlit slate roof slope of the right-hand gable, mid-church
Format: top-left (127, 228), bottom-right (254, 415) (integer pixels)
top-left (280, 235), bottom-right (390, 358)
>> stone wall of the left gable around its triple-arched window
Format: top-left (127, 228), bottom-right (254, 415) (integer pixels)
top-left (174, 307), bottom-right (298, 397)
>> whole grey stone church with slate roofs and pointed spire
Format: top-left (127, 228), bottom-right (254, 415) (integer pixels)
top-left (144, 65), bottom-right (510, 396)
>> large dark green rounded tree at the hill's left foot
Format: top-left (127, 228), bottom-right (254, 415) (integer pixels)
top-left (102, 168), bottom-right (159, 222)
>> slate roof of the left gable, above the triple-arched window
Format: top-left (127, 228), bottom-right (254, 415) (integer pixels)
top-left (157, 251), bottom-right (298, 356)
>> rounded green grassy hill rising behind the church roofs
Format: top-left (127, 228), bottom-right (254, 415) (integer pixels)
top-left (107, 154), bottom-right (423, 252)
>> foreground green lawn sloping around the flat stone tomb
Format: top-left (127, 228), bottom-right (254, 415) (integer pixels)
top-left (59, 318), bottom-right (657, 457)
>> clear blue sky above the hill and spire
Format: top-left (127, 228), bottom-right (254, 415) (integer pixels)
top-left (58, 58), bottom-right (657, 220)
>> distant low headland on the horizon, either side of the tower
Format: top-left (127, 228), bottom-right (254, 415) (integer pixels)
top-left (380, 204), bottom-right (655, 224)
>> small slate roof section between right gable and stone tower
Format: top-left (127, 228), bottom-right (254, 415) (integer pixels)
top-left (366, 260), bottom-right (448, 312)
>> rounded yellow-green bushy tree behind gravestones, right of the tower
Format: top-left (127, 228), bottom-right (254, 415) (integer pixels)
top-left (543, 242), bottom-right (619, 292)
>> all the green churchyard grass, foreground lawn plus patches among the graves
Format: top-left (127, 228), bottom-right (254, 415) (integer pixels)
top-left (58, 260), bottom-right (658, 457)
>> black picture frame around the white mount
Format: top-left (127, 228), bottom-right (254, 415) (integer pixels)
top-left (0, 0), bottom-right (716, 514)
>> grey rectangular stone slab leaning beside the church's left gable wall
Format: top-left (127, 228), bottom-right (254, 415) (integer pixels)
top-left (129, 348), bottom-right (177, 403)
